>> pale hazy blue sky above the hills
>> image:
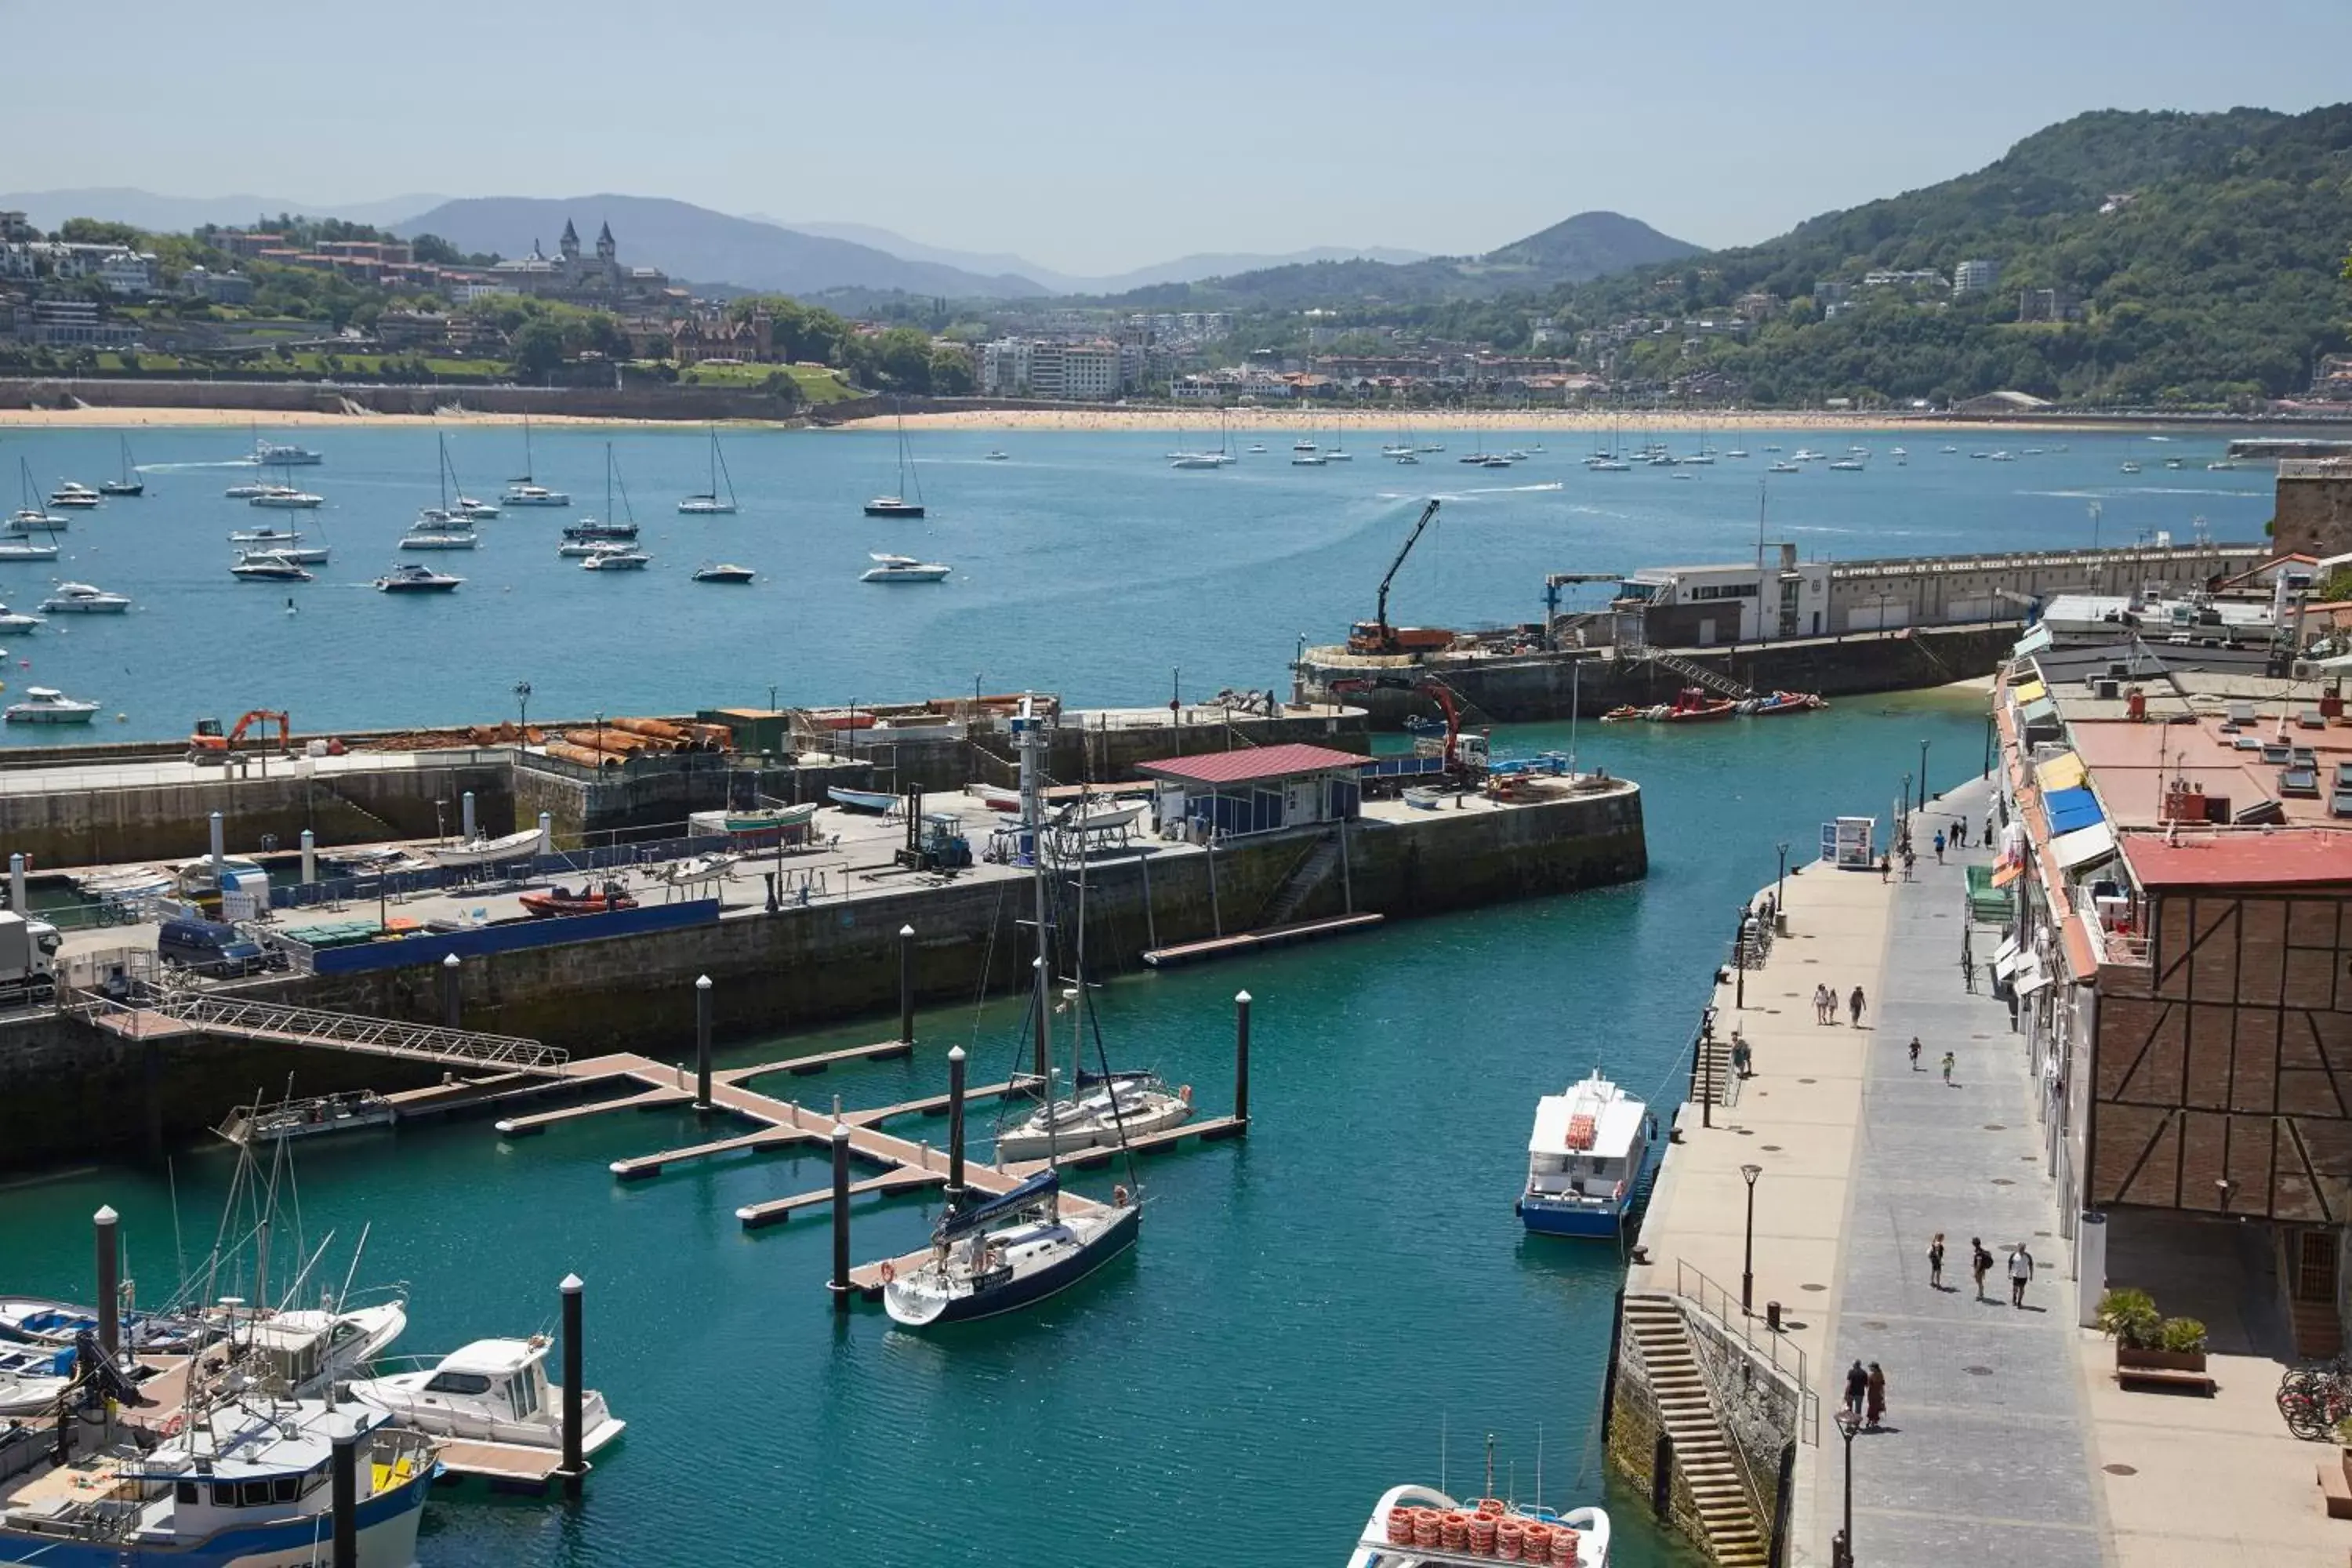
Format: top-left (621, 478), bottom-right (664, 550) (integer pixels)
top-left (0, 0), bottom-right (2352, 273)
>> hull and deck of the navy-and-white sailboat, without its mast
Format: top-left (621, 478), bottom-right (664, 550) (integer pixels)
top-left (882, 1171), bottom-right (1143, 1328)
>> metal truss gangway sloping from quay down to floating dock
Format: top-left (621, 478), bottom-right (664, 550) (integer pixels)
top-left (78, 987), bottom-right (572, 1076)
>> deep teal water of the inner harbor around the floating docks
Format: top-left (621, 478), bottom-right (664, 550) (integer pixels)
top-left (0, 700), bottom-right (1994, 1568)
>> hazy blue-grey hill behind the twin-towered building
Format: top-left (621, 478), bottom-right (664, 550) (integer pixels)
top-left (395, 195), bottom-right (1047, 299)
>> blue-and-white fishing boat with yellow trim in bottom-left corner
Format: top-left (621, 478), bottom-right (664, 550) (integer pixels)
top-left (0, 1401), bottom-right (440, 1568)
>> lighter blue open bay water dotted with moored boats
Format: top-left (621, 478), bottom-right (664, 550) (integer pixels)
top-left (0, 426), bottom-right (2270, 746)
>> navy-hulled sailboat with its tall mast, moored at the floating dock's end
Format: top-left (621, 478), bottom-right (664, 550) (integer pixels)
top-left (882, 699), bottom-right (1143, 1328)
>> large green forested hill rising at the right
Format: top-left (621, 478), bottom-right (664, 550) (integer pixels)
top-left (1550, 103), bottom-right (2352, 405)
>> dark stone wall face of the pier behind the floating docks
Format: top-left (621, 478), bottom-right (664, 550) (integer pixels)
top-left (0, 781), bottom-right (1649, 1168)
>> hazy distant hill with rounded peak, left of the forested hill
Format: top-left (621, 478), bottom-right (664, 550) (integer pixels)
top-left (1091, 212), bottom-right (1698, 310)
